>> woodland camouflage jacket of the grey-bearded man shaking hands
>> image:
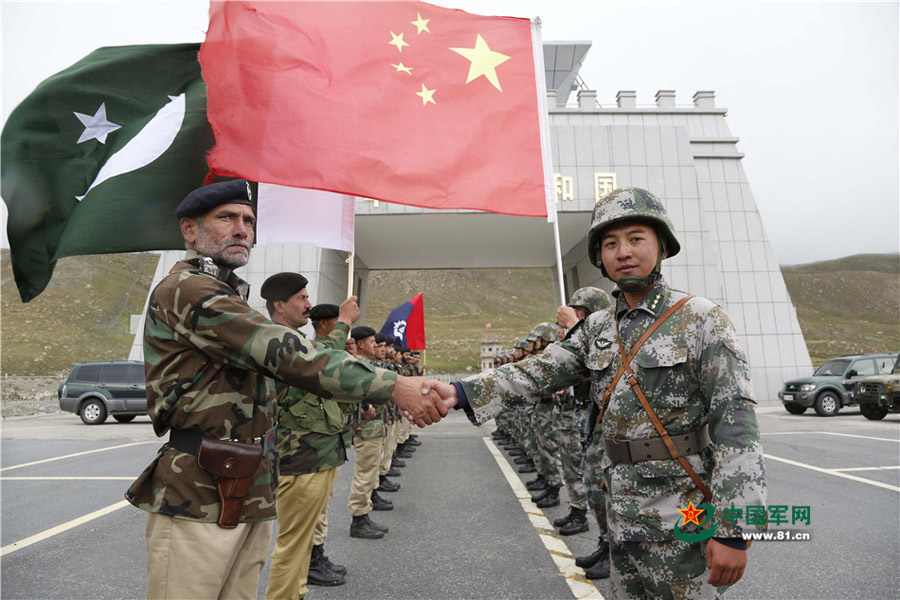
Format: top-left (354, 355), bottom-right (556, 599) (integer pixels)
top-left (125, 251), bottom-right (397, 523)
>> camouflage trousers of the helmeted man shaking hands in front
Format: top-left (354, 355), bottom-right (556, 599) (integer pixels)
top-left (609, 540), bottom-right (729, 600)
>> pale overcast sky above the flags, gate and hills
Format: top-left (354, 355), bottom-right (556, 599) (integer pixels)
top-left (2, 0), bottom-right (900, 264)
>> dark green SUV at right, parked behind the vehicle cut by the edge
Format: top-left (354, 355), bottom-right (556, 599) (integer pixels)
top-left (778, 353), bottom-right (898, 417)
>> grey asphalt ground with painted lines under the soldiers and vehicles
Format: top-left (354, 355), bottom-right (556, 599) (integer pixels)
top-left (0, 407), bottom-right (900, 600)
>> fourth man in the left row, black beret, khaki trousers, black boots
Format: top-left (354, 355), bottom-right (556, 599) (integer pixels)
top-left (347, 325), bottom-right (393, 540)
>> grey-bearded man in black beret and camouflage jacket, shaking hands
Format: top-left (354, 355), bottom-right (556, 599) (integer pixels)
top-left (125, 180), bottom-right (445, 598)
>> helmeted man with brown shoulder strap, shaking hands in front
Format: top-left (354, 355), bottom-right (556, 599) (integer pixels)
top-left (429, 188), bottom-right (766, 598)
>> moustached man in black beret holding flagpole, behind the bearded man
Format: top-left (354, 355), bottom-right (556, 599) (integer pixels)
top-left (260, 272), bottom-right (359, 600)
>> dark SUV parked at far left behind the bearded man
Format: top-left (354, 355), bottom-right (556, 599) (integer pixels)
top-left (57, 360), bottom-right (147, 425)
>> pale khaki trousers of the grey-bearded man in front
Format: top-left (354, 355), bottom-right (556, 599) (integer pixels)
top-left (146, 513), bottom-right (272, 600)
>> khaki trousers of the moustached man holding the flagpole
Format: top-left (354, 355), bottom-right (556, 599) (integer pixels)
top-left (266, 469), bottom-right (337, 600)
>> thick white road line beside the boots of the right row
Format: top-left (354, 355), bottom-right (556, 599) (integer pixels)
top-left (482, 438), bottom-right (603, 600)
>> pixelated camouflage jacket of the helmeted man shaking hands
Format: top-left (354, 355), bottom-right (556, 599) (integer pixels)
top-left (461, 280), bottom-right (766, 541)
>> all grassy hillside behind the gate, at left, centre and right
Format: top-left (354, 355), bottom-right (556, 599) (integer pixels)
top-left (0, 250), bottom-right (900, 375)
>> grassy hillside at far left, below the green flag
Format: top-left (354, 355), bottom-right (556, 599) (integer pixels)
top-left (0, 250), bottom-right (158, 375)
